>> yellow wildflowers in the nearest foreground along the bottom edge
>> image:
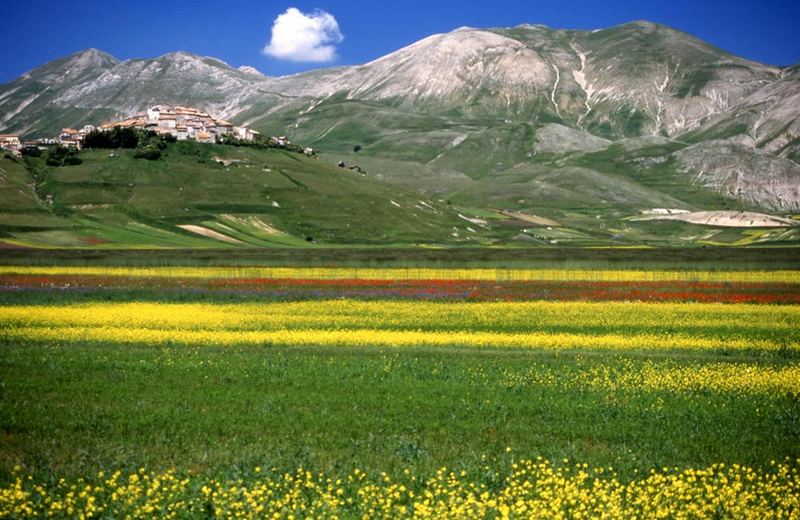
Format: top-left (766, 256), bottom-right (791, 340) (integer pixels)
top-left (0, 460), bottom-right (800, 519)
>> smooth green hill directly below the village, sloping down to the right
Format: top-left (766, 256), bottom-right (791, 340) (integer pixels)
top-left (0, 142), bottom-right (500, 247)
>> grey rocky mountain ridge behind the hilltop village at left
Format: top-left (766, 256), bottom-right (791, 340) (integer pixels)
top-left (0, 49), bottom-right (264, 136)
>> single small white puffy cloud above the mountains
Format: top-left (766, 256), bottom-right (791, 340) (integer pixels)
top-left (264, 7), bottom-right (344, 62)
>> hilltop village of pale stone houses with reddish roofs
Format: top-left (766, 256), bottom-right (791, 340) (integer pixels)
top-left (0, 105), bottom-right (304, 155)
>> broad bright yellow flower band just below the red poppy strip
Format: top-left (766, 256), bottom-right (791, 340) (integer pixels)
top-left (0, 300), bottom-right (800, 350)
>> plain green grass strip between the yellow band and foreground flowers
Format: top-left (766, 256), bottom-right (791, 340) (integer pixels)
top-left (0, 342), bottom-right (800, 481)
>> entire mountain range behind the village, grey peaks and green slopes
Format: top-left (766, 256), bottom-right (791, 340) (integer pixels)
top-left (0, 22), bottom-right (800, 248)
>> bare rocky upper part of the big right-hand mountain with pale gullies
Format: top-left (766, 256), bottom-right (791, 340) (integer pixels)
top-left (244, 22), bottom-right (781, 134)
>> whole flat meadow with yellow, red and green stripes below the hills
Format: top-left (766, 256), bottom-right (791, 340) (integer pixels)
top-left (0, 257), bottom-right (800, 518)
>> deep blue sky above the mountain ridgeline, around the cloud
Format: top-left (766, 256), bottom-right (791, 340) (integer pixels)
top-left (0, 0), bottom-right (800, 82)
